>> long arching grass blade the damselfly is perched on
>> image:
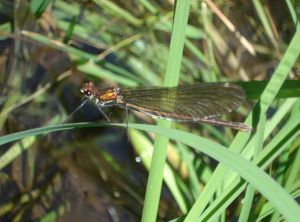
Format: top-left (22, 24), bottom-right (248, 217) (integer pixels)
top-left (0, 123), bottom-right (300, 222)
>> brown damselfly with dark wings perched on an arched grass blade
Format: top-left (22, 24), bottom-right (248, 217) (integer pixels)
top-left (70, 81), bottom-right (252, 131)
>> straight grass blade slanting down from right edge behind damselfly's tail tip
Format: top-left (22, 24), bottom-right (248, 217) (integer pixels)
top-left (185, 26), bottom-right (300, 221)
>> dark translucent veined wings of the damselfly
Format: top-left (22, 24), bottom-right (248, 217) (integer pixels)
top-left (119, 83), bottom-right (245, 121)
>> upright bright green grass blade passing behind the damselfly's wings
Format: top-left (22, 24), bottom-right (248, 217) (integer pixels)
top-left (142, 0), bottom-right (190, 222)
